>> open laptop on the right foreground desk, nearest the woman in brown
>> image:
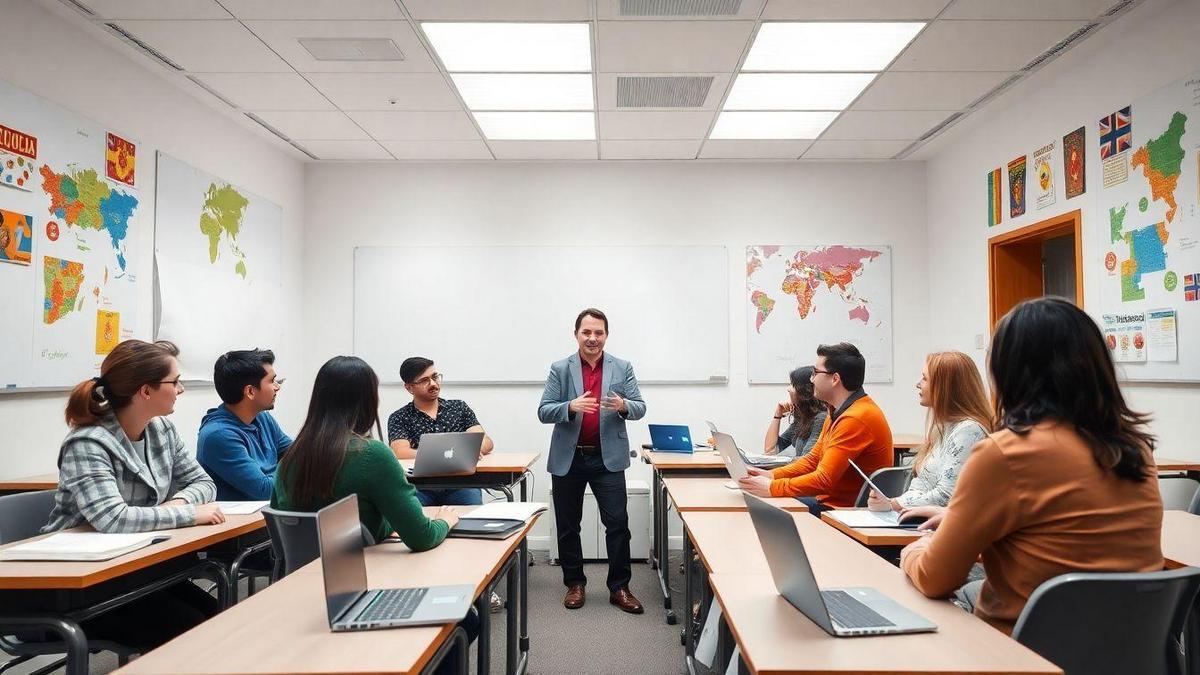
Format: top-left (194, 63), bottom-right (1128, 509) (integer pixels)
top-left (743, 492), bottom-right (937, 638)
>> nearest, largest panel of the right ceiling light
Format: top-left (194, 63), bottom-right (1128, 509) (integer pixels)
top-left (742, 22), bottom-right (925, 71)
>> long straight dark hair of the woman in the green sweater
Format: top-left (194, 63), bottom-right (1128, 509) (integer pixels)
top-left (280, 357), bottom-right (379, 510)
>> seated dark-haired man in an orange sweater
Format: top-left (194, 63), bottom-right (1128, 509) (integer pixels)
top-left (738, 342), bottom-right (892, 514)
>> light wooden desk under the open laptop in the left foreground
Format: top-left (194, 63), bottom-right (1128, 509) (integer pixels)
top-left (119, 509), bottom-right (536, 675)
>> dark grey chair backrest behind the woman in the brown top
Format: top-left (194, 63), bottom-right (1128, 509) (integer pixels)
top-left (1013, 567), bottom-right (1200, 675)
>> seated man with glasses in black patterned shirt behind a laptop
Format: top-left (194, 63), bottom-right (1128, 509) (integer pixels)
top-left (388, 357), bottom-right (493, 506)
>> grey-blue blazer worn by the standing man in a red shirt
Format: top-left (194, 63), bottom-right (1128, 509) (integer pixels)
top-left (538, 352), bottom-right (646, 476)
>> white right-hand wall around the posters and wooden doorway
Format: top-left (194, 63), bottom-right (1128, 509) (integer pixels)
top-left (926, 0), bottom-right (1200, 459)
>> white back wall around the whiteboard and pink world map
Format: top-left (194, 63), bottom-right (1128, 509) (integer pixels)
top-left (305, 162), bottom-right (929, 540)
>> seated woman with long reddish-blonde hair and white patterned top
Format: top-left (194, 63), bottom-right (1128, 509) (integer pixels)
top-left (866, 352), bottom-right (991, 510)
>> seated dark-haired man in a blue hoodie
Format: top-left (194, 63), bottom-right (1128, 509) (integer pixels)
top-left (196, 350), bottom-right (292, 501)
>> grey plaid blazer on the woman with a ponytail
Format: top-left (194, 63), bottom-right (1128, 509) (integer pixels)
top-left (42, 414), bottom-right (217, 532)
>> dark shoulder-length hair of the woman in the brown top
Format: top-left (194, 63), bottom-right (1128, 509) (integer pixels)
top-left (989, 298), bottom-right (1154, 480)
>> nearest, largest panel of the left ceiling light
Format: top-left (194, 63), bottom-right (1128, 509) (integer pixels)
top-left (421, 23), bottom-right (592, 72)
